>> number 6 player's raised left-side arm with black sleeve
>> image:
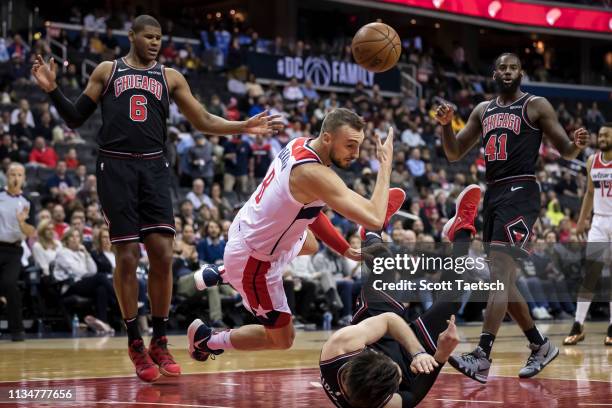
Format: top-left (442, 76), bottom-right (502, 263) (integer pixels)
top-left (32, 55), bottom-right (107, 129)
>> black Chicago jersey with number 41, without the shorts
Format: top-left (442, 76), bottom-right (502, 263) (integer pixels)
top-left (481, 93), bottom-right (542, 183)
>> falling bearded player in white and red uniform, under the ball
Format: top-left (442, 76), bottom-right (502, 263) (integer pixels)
top-left (188, 108), bottom-right (405, 361)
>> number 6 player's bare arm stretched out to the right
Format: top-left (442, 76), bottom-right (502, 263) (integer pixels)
top-left (164, 68), bottom-right (284, 136)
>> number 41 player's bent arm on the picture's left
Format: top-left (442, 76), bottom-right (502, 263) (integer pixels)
top-left (435, 102), bottom-right (488, 162)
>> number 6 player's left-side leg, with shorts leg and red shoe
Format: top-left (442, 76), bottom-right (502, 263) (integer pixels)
top-left (96, 154), bottom-right (160, 382)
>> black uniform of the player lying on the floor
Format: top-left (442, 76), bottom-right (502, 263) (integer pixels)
top-left (319, 291), bottom-right (459, 408)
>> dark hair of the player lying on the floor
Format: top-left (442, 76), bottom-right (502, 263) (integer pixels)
top-left (343, 352), bottom-right (400, 408)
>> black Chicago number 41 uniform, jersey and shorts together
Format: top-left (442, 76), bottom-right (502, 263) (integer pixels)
top-left (481, 93), bottom-right (542, 255)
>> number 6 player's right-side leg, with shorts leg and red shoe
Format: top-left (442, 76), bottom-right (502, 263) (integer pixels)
top-left (138, 157), bottom-right (181, 377)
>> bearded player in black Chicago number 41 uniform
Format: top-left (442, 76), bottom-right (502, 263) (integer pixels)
top-left (436, 53), bottom-right (588, 383)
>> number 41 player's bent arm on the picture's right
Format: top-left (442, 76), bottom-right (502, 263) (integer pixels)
top-left (527, 97), bottom-right (589, 160)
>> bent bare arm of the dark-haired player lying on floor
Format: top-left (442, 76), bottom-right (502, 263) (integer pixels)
top-left (321, 313), bottom-right (439, 374)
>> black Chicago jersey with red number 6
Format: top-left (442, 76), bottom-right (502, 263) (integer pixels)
top-left (97, 58), bottom-right (170, 153)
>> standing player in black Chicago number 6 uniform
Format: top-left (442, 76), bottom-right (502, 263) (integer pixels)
top-left (32, 15), bottom-right (282, 382)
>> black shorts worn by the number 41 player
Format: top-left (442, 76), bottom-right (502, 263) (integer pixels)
top-left (482, 179), bottom-right (540, 257)
